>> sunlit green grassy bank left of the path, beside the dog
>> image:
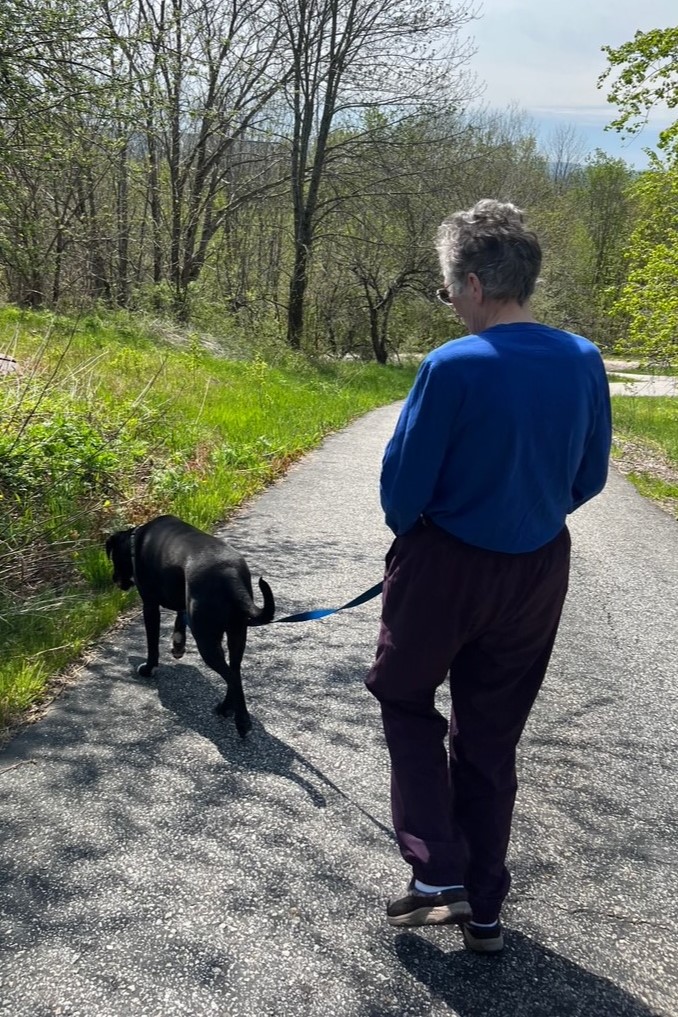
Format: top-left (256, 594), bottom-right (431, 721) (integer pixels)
top-left (0, 308), bottom-right (415, 727)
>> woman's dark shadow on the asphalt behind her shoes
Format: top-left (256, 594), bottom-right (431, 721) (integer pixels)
top-left (392, 930), bottom-right (661, 1017)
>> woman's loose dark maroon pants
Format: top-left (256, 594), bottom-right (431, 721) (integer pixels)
top-left (366, 523), bottom-right (570, 922)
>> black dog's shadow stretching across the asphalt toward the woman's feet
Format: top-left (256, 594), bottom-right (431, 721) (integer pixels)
top-left (130, 657), bottom-right (393, 840)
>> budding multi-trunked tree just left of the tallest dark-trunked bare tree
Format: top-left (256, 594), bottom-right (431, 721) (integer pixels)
top-left (105, 0), bottom-right (286, 316)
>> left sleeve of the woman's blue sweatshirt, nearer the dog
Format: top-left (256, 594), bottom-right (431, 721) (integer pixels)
top-left (380, 360), bottom-right (454, 536)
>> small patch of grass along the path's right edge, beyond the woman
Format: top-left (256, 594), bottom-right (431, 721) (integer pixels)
top-left (612, 396), bottom-right (678, 518)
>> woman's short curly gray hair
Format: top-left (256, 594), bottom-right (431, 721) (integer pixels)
top-left (435, 198), bottom-right (542, 304)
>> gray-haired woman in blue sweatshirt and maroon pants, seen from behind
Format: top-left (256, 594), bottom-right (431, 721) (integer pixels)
top-left (367, 200), bottom-right (611, 952)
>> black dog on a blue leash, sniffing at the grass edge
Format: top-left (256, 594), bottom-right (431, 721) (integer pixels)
top-left (106, 516), bottom-right (275, 738)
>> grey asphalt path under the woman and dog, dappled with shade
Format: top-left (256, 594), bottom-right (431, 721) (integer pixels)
top-left (0, 407), bottom-right (678, 1017)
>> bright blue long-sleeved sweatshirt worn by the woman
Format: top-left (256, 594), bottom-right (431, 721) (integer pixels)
top-left (381, 322), bottom-right (612, 553)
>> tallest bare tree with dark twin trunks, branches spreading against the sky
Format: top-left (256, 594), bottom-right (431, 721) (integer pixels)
top-left (278, 0), bottom-right (474, 348)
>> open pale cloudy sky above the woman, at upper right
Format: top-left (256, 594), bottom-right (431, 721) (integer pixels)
top-left (465, 0), bottom-right (678, 169)
